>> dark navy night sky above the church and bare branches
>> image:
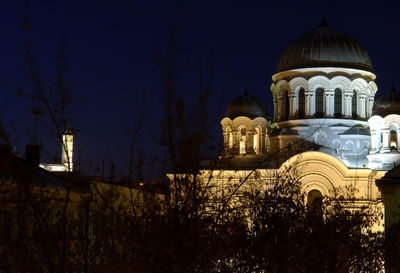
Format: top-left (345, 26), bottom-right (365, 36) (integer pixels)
top-left (0, 0), bottom-right (400, 174)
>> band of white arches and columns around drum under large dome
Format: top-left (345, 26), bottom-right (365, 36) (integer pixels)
top-left (273, 75), bottom-right (377, 121)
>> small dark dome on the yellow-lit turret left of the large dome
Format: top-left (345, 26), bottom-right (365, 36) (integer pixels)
top-left (225, 89), bottom-right (266, 119)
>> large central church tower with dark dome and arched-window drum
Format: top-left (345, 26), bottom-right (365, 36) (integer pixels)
top-left (271, 20), bottom-right (377, 168)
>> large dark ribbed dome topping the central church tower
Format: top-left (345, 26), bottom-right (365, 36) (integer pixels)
top-left (276, 21), bottom-right (372, 72)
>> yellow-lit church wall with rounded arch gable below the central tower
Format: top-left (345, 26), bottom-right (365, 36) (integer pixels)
top-left (202, 152), bottom-right (386, 229)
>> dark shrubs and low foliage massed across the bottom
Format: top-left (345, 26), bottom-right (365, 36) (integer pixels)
top-left (0, 157), bottom-right (383, 272)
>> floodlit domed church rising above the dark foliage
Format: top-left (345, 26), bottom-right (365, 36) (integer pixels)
top-left (214, 20), bottom-right (400, 208)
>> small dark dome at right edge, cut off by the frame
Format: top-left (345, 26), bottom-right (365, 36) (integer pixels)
top-left (372, 87), bottom-right (400, 117)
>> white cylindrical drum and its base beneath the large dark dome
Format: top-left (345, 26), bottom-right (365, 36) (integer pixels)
top-left (271, 67), bottom-right (378, 168)
